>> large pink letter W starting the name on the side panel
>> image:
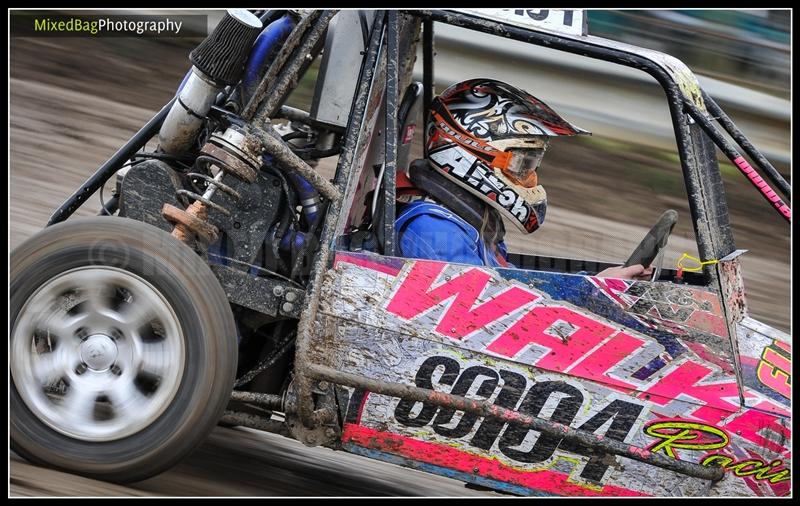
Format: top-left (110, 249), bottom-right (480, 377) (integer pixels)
top-left (386, 261), bottom-right (541, 339)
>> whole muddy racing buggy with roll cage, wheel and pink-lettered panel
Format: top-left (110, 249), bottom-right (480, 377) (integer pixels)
top-left (9, 9), bottom-right (791, 496)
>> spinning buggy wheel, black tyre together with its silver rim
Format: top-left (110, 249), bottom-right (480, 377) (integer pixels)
top-left (9, 217), bottom-right (237, 482)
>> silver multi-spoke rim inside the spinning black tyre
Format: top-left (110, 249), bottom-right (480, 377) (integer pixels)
top-left (10, 266), bottom-right (186, 441)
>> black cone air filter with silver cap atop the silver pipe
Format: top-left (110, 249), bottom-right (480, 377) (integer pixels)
top-left (189, 9), bottom-right (261, 85)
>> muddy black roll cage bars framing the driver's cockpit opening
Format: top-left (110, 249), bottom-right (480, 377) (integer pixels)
top-left (354, 10), bottom-right (791, 279)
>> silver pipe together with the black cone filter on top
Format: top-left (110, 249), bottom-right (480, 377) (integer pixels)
top-left (158, 9), bottom-right (262, 155)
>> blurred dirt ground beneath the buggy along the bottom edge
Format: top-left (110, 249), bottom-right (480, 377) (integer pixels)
top-left (10, 427), bottom-right (488, 497)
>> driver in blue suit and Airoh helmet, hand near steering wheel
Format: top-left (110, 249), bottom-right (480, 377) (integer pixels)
top-left (395, 79), bottom-right (652, 280)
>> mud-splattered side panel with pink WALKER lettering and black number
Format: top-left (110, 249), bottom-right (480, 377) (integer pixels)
top-left (311, 254), bottom-right (790, 496)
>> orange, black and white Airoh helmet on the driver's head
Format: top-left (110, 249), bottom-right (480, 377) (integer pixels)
top-left (425, 79), bottom-right (590, 234)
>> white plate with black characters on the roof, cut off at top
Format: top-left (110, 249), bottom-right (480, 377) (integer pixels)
top-left (454, 9), bottom-right (588, 37)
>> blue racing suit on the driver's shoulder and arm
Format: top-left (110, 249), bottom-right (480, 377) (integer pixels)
top-left (394, 200), bottom-right (513, 267)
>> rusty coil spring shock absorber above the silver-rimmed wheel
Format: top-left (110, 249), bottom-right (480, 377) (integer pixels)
top-left (161, 125), bottom-right (261, 246)
